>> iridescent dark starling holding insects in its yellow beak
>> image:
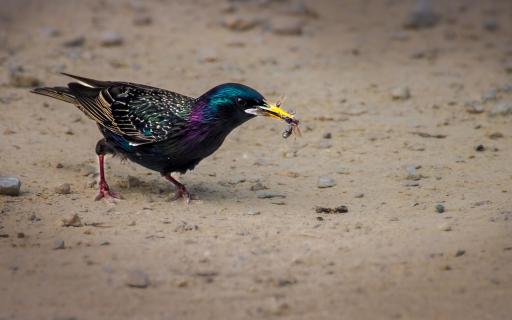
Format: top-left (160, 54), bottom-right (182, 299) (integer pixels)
top-left (32, 73), bottom-right (300, 203)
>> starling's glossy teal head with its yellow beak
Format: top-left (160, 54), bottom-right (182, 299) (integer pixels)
top-left (198, 83), bottom-right (299, 126)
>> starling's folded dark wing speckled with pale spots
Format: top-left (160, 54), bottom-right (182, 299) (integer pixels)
top-left (36, 75), bottom-right (195, 144)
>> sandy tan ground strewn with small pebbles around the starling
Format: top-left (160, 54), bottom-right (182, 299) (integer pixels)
top-left (0, 0), bottom-right (512, 320)
